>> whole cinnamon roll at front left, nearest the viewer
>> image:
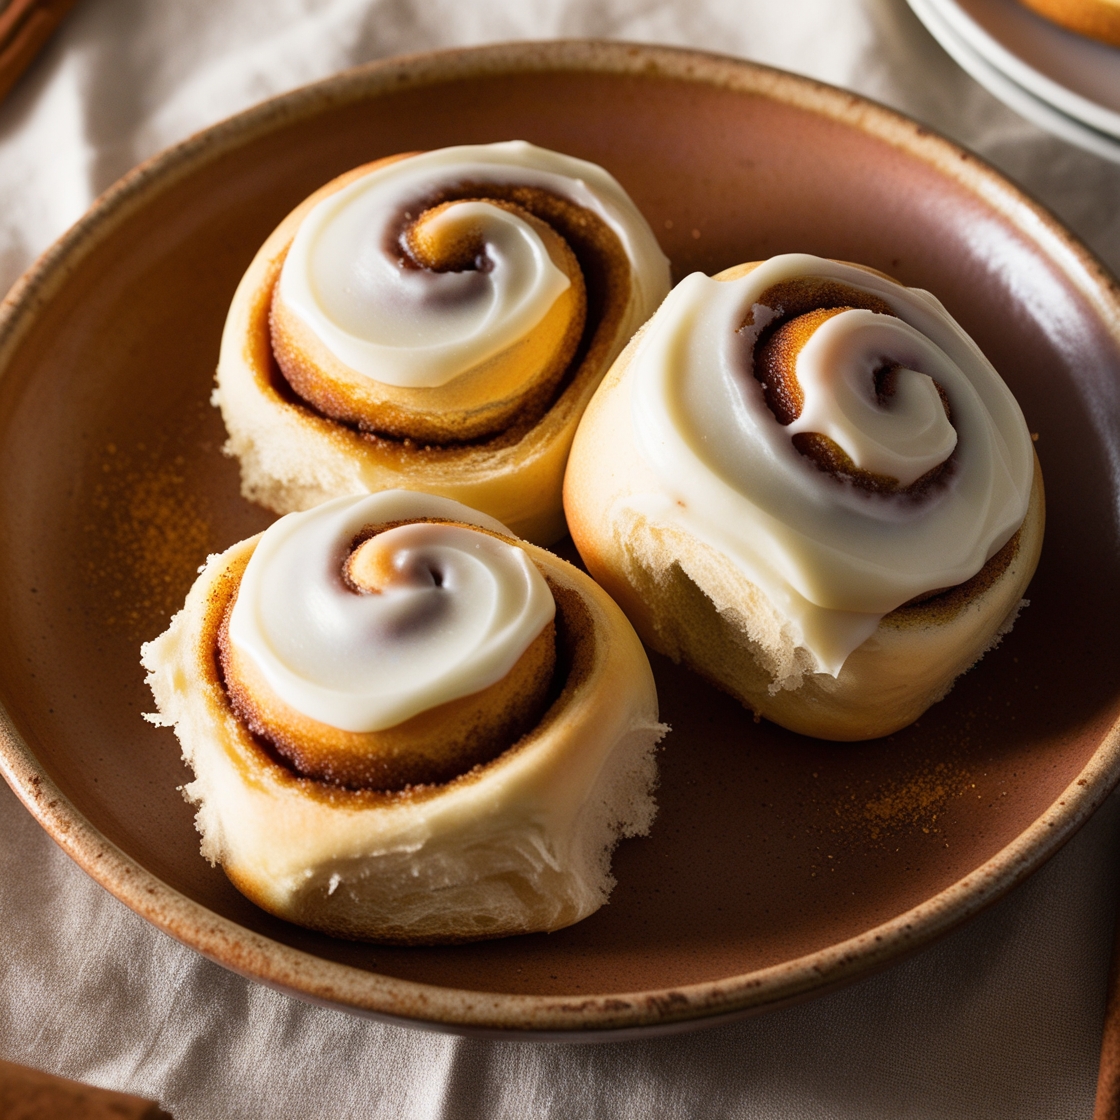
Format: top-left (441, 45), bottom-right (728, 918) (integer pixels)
top-left (142, 491), bottom-right (665, 943)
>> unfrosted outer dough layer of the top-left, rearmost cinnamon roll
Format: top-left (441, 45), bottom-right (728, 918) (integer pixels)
top-left (213, 156), bottom-right (669, 544)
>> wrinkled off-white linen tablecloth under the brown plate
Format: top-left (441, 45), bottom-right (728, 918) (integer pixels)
top-left (0, 0), bottom-right (1120, 1120)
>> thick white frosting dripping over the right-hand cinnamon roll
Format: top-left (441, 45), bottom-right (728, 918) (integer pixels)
top-left (625, 254), bottom-right (1034, 675)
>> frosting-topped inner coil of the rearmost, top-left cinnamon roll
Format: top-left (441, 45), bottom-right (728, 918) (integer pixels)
top-left (272, 141), bottom-right (666, 444)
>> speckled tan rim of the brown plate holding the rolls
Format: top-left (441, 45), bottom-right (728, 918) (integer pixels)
top-left (0, 39), bottom-right (1120, 1042)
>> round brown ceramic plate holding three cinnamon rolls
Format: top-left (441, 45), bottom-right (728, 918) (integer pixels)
top-left (0, 43), bottom-right (1120, 1037)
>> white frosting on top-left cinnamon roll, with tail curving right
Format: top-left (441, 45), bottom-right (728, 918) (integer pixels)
top-left (280, 140), bottom-right (669, 388)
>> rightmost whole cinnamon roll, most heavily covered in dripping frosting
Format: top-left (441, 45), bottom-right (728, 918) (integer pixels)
top-left (564, 254), bottom-right (1044, 739)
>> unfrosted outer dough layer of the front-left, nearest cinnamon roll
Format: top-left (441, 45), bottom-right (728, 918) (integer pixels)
top-left (142, 521), bottom-right (666, 944)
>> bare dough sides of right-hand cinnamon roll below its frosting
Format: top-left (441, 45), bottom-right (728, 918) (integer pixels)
top-left (564, 267), bottom-right (1045, 740)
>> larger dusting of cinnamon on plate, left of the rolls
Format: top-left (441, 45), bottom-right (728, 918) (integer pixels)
top-left (85, 444), bottom-right (214, 638)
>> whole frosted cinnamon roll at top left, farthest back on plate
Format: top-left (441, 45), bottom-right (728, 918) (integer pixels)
top-left (214, 141), bottom-right (669, 543)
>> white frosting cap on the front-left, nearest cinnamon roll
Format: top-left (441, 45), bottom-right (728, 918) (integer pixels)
top-left (230, 491), bottom-right (556, 731)
